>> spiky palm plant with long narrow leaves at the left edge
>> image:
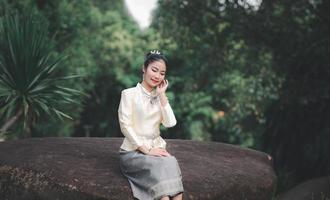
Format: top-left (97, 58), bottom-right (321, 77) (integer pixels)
top-left (0, 14), bottom-right (82, 137)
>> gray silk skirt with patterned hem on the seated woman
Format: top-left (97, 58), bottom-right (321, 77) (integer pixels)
top-left (119, 149), bottom-right (183, 200)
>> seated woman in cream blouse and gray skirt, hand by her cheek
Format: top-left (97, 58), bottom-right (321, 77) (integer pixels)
top-left (118, 50), bottom-right (183, 200)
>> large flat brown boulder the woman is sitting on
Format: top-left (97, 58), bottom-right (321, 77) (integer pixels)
top-left (0, 138), bottom-right (276, 200)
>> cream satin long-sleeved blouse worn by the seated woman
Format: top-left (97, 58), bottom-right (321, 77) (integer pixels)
top-left (118, 83), bottom-right (176, 151)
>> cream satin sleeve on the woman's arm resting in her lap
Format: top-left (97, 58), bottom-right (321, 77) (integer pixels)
top-left (118, 90), bottom-right (143, 148)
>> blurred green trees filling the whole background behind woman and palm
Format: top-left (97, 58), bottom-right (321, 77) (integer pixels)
top-left (0, 0), bottom-right (330, 195)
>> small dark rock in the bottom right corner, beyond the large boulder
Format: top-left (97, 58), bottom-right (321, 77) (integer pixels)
top-left (278, 176), bottom-right (330, 200)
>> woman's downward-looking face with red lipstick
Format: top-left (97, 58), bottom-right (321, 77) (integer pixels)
top-left (143, 60), bottom-right (166, 87)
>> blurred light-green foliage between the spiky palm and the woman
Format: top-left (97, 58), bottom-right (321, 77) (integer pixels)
top-left (0, 0), bottom-right (160, 136)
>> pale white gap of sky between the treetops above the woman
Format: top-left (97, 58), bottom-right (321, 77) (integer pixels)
top-left (125, 0), bottom-right (157, 29)
